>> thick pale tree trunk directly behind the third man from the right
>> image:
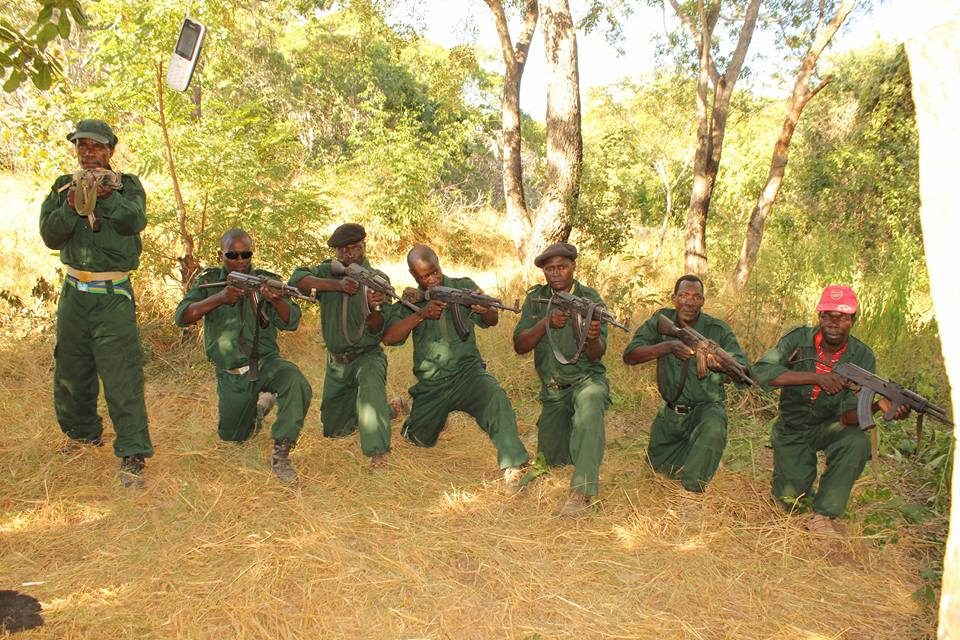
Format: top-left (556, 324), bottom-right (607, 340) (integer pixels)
top-left (524, 0), bottom-right (583, 263)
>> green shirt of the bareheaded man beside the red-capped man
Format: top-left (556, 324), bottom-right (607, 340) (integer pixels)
top-left (623, 309), bottom-right (748, 405)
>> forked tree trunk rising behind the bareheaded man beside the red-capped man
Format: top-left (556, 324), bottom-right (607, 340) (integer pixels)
top-left (666, 0), bottom-right (760, 274)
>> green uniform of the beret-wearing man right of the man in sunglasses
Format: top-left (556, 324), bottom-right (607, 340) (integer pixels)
top-left (290, 258), bottom-right (391, 456)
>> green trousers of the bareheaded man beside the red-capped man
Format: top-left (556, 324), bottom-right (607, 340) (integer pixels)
top-left (647, 402), bottom-right (727, 491)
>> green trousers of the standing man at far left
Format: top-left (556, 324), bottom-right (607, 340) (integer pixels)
top-left (53, 279), bottom-right (153, 457)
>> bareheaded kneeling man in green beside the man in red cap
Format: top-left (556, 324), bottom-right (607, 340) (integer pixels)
top-left (623, 275), bottom-right (747, 492)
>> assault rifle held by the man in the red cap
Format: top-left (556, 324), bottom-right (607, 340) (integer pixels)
top-left (833, 362), bottom-right (953, 438)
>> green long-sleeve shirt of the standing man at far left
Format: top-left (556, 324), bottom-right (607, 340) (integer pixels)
top-left (40, 173), bottom-right (147, 271)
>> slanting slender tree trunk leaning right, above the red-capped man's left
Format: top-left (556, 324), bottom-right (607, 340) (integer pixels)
top-left (731, 0), bottom-right (857, 291)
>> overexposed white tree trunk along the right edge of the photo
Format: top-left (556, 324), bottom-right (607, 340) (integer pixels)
top-left (906, 10), bottom-right (960, 640)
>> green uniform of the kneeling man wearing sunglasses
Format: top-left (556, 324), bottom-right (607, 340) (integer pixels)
top-left (175, 267), bottom-right (313, 442)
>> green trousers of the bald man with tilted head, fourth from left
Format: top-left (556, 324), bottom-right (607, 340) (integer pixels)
top-left (401, 366), bottom-right (529, 469)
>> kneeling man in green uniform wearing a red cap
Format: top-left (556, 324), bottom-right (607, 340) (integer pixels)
top-left (753, 285), bottom-right (910, 534)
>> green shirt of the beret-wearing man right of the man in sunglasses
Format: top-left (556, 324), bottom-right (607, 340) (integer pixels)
top-left (289, 258), bottom-right (390, 353)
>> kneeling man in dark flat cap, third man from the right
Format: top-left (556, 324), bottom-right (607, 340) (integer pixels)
top-left (513, 242), bottom-right (610, 517)
